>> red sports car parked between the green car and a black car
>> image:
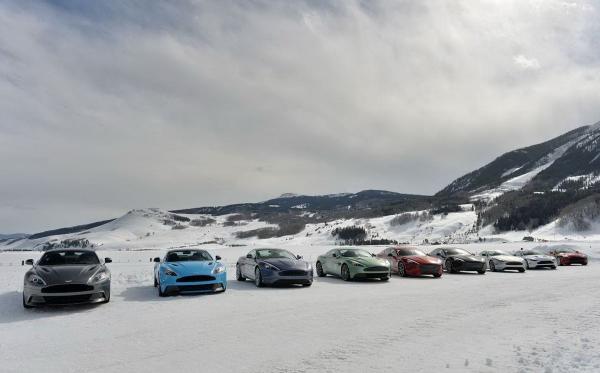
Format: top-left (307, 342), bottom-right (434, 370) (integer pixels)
top-left (377, 246), bottom-right (442, 277)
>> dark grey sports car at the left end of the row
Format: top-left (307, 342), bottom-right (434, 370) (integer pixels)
top-left (23, 249), bottom-right (112, 308)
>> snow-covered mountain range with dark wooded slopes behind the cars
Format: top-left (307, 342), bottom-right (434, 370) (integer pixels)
top-left (5, 123), bottom-right (600, 250)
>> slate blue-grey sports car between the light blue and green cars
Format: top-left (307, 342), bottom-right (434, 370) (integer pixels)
top-left (235, 249), bottom-right (313, 287)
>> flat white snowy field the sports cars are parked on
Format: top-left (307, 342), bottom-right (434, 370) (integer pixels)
top-left (0, 243), bottom-right (600, 373)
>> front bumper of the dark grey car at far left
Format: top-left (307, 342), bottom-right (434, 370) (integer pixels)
top-left (23, 281), bottom-right (110, 307)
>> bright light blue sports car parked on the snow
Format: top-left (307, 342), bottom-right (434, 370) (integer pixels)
top-left (154, 249), bottom-right (227, 297)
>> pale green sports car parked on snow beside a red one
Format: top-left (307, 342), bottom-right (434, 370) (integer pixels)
top-left (316, 249), bottom-right (391, 281)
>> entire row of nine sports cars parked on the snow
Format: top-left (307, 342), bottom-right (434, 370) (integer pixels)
top-left (23, 243), bottom-right (588, 308)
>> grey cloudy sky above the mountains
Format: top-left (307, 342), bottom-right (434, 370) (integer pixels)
top-left (0, 0), bottom-right (600, 233)
